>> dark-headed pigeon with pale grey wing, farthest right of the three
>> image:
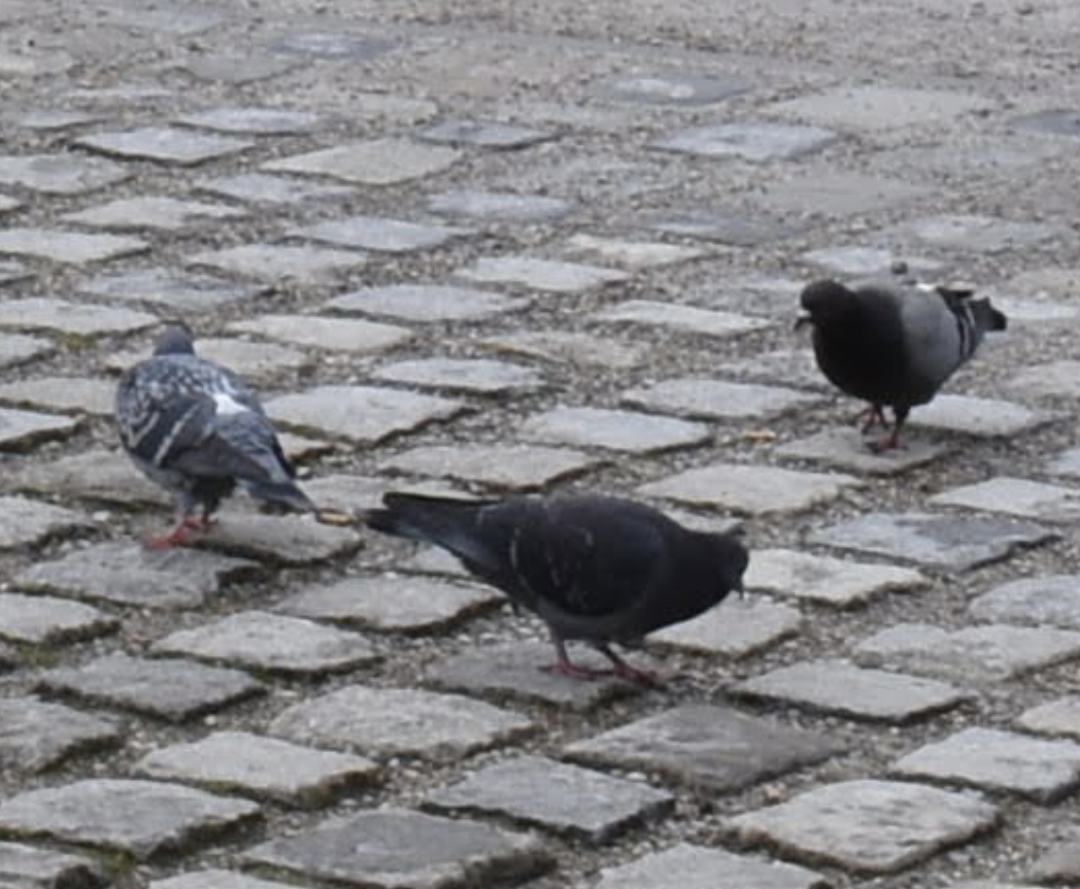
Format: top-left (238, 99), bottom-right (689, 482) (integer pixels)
top-left (796, 280), bottom-right (1007, 450)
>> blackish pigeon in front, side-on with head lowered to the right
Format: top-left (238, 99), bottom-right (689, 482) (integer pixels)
top-left (364, 491), bottom-right (750, 685)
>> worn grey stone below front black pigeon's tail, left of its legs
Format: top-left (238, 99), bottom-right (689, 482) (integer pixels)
top-left (279, 575), bottom-right (502, 633)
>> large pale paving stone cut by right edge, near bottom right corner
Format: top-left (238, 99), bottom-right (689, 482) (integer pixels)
top-left (892, 727), bottom-right (1080, 805)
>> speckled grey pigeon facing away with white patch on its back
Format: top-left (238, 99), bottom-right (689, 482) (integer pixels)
top-left (116, 324), bottom-right (316, 549)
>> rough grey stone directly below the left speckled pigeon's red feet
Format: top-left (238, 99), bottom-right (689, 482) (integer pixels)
top-left (15, 542), bottom-right (255, 609)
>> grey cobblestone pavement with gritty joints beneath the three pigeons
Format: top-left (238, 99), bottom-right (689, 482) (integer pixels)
top-left (0, 0), bottom-right (1080, 889)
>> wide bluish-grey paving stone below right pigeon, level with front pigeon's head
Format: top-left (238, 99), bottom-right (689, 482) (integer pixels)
top-left (807, 512), bottom-right (1055, 571)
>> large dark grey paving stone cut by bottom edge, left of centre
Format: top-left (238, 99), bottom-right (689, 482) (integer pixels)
top-left (245, 808), bottom-right (552, 889)
